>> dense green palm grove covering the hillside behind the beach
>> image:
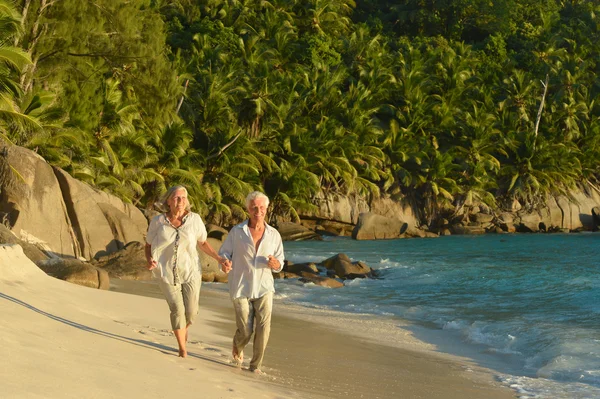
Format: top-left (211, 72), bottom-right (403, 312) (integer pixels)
top-left (0, 0), bottom-right (600, 227)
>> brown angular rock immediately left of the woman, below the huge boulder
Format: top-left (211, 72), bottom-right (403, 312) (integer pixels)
top-left (90, 241), bottom-right (152, 280)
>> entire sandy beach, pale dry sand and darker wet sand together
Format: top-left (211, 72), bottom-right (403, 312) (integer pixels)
top-left (0, 246), bottom-right (516, 399)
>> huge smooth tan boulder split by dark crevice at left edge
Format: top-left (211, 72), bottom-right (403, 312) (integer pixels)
top-left (0, 146), bottom-right (148, 259)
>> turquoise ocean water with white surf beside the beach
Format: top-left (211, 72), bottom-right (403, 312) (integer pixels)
top-left (276, 233), bottom-right (600, 399)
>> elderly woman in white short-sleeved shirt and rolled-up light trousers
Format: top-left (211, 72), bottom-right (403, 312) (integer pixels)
top-left (145, 186), bottom-right (224, 357)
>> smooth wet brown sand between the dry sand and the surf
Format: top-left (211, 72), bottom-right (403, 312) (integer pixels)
top-left (111, 280), bottom-right (517, 399)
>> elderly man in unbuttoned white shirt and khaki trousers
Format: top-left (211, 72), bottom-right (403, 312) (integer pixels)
top-left (219, 191), bottom-right (284, 373)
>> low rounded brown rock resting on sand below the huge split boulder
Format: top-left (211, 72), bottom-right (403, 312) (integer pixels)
top-left (38, 258), bottom-right (110, 290)
